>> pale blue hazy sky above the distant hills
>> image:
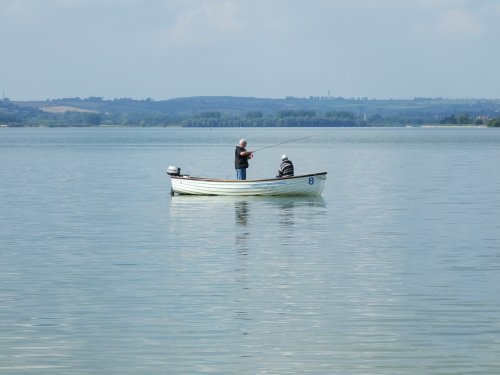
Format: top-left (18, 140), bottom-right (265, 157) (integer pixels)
top-left (0, 0), bottom-right (500, 100)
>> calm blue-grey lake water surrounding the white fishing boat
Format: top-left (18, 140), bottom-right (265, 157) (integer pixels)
top-left (0, 128), bottom-right (500, 375)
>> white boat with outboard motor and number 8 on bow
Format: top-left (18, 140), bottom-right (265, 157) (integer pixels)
top-left (167, 166), bottom-right (326, 196)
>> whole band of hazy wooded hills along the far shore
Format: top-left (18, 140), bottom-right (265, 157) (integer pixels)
top-left (0, 96), bottom-right (500, 129)
